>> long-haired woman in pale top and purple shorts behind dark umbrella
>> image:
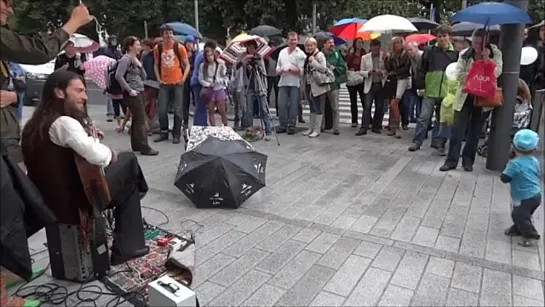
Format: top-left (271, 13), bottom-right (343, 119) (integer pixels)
top-left (199, 48), bottom-right (229, 126)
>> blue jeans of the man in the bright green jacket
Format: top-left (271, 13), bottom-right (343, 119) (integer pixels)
top-left (413, 97), bottom-right (449, 145)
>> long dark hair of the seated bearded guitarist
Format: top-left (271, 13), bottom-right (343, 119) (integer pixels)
top-left (22, 70), bottom-right (89, 147)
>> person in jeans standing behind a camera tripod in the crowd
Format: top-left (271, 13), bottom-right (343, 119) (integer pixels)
top-left (235, 41), bottom-right (272, 141)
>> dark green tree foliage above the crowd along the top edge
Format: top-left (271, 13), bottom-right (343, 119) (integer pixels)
top-left (11, 0), bottom-right (545, 44)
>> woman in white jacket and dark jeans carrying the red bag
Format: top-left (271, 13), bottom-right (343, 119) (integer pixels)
top-left (440, 29), bottom-right (503, 172)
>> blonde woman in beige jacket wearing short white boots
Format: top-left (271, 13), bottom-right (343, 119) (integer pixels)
top-left (302, 37), bottom-right (332, 138)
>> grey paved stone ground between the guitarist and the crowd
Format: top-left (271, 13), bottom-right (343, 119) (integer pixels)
top-left (14, 108), bottom-right (544, 306)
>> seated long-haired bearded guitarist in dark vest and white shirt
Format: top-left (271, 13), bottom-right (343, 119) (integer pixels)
top-left (22, 70), bottom-right (149, 265)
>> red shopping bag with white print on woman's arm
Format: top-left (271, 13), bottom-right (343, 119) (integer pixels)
top-left (464, 60), bottom-right (497, 100)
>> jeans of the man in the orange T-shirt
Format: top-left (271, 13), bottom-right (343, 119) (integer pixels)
top-left (158, 84), bottom-right (184, 137)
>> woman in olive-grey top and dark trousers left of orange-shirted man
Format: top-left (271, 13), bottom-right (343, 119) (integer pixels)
top-left (115, 36), bottom-right (159, 156)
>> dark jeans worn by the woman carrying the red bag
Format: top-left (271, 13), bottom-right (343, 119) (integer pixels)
top-left (445, 95), bottom-right (484, 167)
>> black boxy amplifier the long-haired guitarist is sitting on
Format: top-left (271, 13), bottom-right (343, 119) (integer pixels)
top-left (46, 218), bottom-right (110, 283)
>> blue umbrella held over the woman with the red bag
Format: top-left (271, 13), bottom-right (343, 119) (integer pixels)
top-left (452, 2), bottom-right (532, 26)
